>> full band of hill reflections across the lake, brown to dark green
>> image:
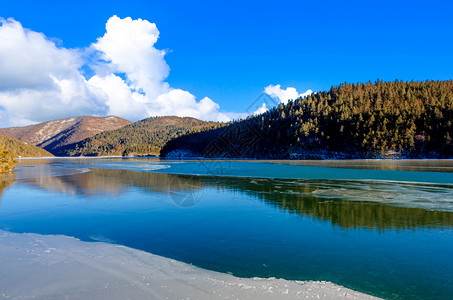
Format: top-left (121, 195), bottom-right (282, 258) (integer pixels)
top-left (22, 169), bottom-right (453, 230)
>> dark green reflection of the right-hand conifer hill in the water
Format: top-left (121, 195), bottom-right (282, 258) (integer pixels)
top-left (195, 178), bottom-right (453, 230)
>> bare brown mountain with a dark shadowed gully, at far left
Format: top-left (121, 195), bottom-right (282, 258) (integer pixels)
top-left (0, 116), bottom-right (132, 153)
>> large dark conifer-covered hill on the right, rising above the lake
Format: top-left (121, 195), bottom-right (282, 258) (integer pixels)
top-left (161, 80), bottom-right (453, 159)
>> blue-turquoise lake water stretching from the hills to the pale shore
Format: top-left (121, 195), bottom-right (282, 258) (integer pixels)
top-left (0, 159), bottom-right (453, 299)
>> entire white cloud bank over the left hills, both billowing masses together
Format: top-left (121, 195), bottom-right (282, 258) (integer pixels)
top-left (0, 16), bottom-right (229, 126)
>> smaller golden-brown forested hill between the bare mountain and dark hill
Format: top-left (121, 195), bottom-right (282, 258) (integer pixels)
top-left (56, 117), bottom-right (224, 156)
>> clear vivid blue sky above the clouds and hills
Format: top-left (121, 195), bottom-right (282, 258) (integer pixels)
top-left (0, 0), bottom-right (453, 123)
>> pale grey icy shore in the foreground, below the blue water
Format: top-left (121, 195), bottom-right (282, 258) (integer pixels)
top-left (0, 230), bottom-right (379, 299)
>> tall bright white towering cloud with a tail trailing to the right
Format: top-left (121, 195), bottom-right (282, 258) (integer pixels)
top-left (89, 16), bottom-right (229, 121)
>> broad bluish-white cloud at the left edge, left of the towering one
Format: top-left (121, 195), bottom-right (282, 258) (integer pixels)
top-left (0, 19), bottom-right (107, 126)
